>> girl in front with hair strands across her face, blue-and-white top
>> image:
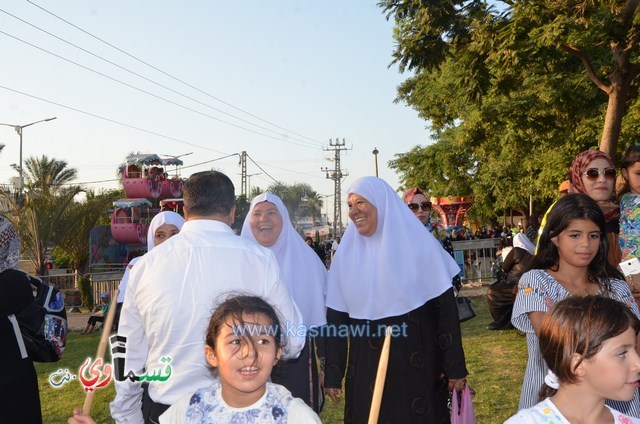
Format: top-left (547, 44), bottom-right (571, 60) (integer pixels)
top-left (160, 296), bottom-right (320, 424)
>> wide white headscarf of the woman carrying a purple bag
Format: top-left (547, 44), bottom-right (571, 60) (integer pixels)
top-left (327, 177), bottom-right (460, 320)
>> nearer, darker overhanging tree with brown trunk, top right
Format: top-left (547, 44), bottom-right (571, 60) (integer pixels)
top-left (379, 0), bottom-right (640, 156)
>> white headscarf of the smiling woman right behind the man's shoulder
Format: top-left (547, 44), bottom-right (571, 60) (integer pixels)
top-left (240, 193), bottom-right (327, 327)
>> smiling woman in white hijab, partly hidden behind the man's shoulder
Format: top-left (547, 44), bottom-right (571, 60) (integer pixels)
top-left (240, 193), bottom-right (327, 412)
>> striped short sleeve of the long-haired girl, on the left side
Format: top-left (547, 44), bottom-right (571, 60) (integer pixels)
top-left (511, 269), bottom-right (552, 333)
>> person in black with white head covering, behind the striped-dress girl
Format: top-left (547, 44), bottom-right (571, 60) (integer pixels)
top-left (487, 233), bottom-right (535, 330)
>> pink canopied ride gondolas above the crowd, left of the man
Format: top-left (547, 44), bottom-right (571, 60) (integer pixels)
top-left (111, 154), bottom-right (184, 245)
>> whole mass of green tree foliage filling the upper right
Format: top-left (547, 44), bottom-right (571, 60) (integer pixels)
top-left (379, 0), bottom-right (640, 222)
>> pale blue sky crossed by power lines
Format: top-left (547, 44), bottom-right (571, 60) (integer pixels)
top-left (0, 0), bottom-right (429, 217)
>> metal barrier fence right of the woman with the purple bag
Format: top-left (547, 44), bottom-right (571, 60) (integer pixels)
top-left (451, 239), bottom-right (500, 284)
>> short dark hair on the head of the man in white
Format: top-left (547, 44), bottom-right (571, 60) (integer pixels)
top-left (182, 171), bottom-right (236, 216)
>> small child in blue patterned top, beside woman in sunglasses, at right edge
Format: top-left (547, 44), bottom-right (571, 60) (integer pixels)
top-left (619, 143), bottom-right (640, 268)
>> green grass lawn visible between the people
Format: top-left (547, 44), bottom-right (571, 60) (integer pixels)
top-left (36, 297), bottom-right (527, 424)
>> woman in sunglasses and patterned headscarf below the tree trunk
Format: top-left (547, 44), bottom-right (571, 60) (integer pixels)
top-left (569, 150), bottom-right (622, 267)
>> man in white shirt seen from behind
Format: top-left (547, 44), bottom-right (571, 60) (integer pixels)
top-left (110, 171), bottom-right (304, 424)
